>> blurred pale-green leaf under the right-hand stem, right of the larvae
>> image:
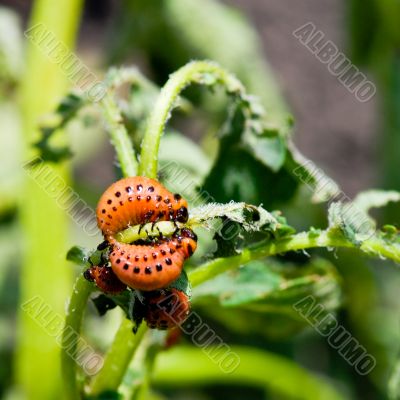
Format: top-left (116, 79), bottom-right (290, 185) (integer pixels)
top-left (194, 259), bottom-right (341, 314)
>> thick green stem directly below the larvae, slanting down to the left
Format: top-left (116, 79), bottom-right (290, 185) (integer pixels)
top-left (90, 318), bottom-right (147, 395)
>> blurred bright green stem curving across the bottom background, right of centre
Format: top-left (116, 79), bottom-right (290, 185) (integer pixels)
top-left (152, 346), bottom-right (347, 400)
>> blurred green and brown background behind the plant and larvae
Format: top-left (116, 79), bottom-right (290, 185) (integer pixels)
top-left (0, 0), bottom-right (400, 400)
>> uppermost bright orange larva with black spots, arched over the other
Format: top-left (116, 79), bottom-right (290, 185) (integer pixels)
top-left (96, 176), bottom-right (188, 238)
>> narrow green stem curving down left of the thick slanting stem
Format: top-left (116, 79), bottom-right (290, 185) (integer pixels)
top-left (61, 275), bottom-right (94, 400)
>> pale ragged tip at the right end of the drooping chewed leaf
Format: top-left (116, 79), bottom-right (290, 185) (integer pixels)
top-left (286, 142), bottom-right (340, 203)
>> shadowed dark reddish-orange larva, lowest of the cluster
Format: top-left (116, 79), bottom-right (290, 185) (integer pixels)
top-left (144, 289), bottom-right (190, 330)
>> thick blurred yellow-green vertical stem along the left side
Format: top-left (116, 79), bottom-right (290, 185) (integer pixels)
top-left (14, 0), bottom-right (82, 400)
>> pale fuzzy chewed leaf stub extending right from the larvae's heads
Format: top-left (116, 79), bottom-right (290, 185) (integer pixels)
top-left (188, 201), bottom-right (278, 231)
